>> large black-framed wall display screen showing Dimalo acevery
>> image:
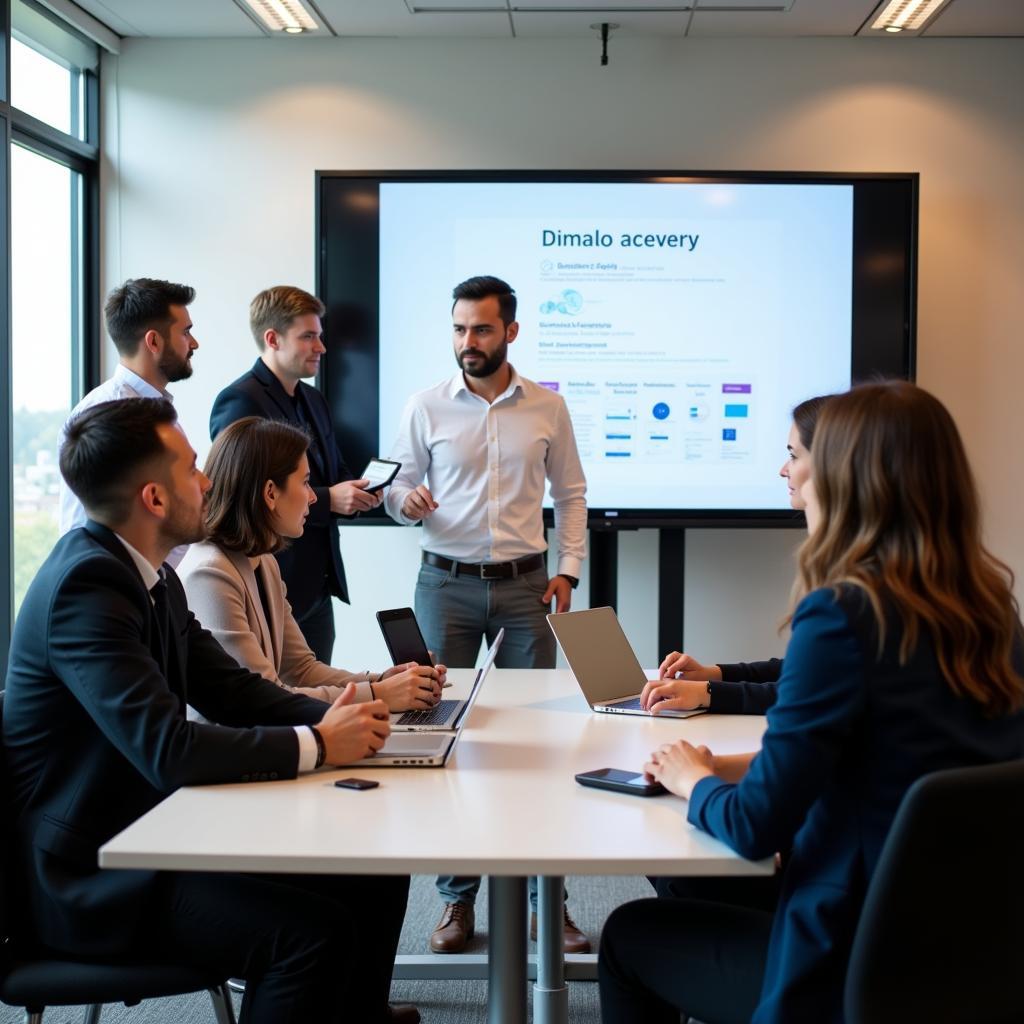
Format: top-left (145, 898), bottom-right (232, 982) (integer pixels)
top-left (317, 174), bottom-right (916, 525)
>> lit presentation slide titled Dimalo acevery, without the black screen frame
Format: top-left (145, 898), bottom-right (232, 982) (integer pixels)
top-left (379, 182), bottom-right (853, 511)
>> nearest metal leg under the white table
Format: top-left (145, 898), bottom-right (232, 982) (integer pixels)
top-left (487, 874), bottom-right (526, 1024)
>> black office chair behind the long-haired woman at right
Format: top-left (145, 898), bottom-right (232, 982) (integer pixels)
top-left (845, 761), bottom-right (1024, 1024)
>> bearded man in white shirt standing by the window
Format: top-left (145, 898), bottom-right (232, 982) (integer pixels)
top-left (59, 278), bottom-right (199, 565)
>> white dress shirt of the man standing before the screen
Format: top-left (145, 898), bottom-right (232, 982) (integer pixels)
top-left (384, 368), bottom-right (587, 577)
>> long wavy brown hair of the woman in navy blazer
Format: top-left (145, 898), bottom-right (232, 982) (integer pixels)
top-left (794, 381), bottom-right (1024, 715)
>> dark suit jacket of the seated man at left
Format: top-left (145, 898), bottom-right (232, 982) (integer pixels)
top-left (3, 522), bottom-right (325, 955)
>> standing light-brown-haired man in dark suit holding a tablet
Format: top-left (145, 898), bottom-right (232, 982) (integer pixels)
top-left (210, 285), bottom-right (380, 664)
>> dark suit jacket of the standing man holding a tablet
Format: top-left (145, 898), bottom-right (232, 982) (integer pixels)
top-left (210, 359), bottom-right (355, 620)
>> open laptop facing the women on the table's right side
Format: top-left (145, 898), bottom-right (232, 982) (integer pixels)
top-left (548, 608), bottom-right (703, 718)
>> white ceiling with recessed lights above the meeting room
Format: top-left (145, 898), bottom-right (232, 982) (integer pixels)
top-left (61, 0), bottom-right (1024, 44)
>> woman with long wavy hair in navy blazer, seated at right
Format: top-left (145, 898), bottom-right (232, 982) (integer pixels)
top-left (600, 382), bottom-right (1024, 1024)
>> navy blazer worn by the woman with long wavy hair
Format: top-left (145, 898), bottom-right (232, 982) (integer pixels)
top-left (688, 589), bottom-right (1024, 1024)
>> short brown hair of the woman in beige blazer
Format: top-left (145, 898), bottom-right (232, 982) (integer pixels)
top-left (203, 416), bottom-right (309, 558)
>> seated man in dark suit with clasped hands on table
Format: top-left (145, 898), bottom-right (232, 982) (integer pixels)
top-left (3, 398), bottom-right (417, 1024)
